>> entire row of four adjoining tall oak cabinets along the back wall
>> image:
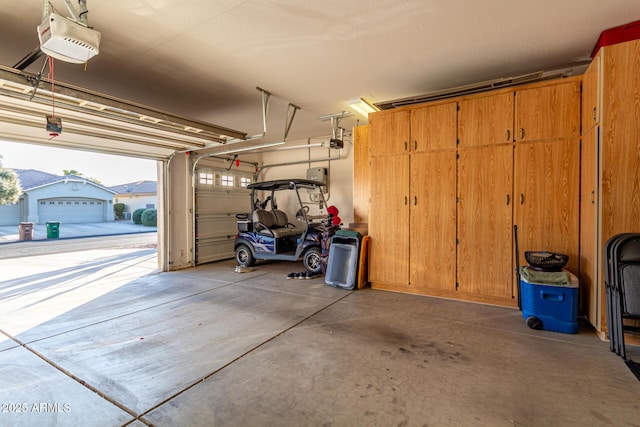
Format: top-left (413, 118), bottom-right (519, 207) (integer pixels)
top-left (369, 77), bottom-right (581, 307)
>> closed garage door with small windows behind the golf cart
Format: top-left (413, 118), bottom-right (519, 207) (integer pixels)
top-left (195, 166), bottom-right (253, 264)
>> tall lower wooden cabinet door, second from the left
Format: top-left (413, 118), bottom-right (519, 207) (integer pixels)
top-left (409, 150), bottom-right (456, 291)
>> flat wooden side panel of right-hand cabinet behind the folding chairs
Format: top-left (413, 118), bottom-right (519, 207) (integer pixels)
top-left (593, 40), bottom-right (640, 343)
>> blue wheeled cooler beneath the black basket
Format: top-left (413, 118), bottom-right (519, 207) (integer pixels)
top-left (520, 267), bottom-right (579, 334)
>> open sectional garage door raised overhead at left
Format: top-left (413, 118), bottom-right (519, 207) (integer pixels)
top-left (0, 66), bottom-right (246, 160)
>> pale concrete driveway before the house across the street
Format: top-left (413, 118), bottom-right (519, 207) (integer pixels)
top-left (0, 221), bottom-right (157, 244)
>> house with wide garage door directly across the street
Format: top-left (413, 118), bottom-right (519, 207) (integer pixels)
top-left (0, 169), bottom-right (115, 225)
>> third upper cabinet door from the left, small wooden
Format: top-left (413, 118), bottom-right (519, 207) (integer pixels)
top-left (458, 92), bottom-right (513, 147)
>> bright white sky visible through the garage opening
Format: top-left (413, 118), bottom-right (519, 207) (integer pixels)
top-left (0, 140), bottom-right (157, 187)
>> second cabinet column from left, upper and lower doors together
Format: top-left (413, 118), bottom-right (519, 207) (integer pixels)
top-left (409, 102), bottom-right (457, 293)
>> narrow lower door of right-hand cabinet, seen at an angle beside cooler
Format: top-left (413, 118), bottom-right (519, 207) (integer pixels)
top-left (580, 126), bottom-right (601, 329)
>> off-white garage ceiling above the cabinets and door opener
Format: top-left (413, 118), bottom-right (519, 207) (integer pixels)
top-left (0, 0), bottom-right (640, 145)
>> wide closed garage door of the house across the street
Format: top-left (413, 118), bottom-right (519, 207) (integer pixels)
top-left (38, 198), bottom-right (106, 224)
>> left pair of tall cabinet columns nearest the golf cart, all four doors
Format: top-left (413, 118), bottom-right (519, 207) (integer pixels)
top-left (369, 102), bottom-right (457, 293)
